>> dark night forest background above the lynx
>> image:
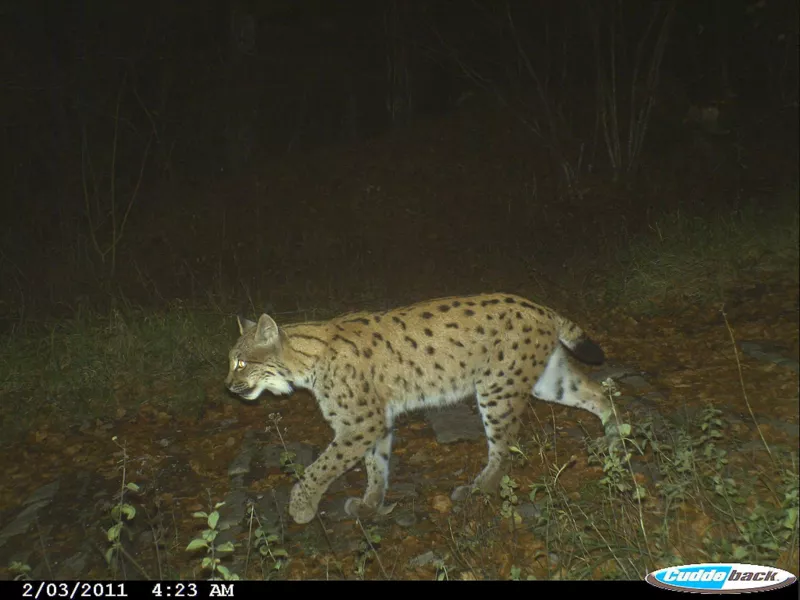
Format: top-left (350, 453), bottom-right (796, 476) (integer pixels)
top-left (0, 0), bottom-right (798, 322)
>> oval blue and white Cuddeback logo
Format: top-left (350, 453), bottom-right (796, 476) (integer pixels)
top-left (645, 563), bottom-right (797, 594)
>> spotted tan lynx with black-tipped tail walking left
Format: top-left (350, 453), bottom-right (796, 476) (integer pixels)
top-left (225, 294), bottom-right (611, 523)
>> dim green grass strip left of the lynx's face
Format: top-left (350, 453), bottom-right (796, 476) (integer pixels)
top-left (0, 307), bottom-right (231, 437)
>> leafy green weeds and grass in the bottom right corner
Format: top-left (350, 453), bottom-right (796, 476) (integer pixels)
top-left (472, 400), bottom-right (800, 580)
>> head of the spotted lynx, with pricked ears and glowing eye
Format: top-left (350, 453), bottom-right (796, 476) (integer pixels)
top-left (225, 314), bottom-right (293, 401)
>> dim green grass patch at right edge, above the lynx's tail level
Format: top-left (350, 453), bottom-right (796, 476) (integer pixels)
top-left (606, 186), bottom-right (800, 312)
